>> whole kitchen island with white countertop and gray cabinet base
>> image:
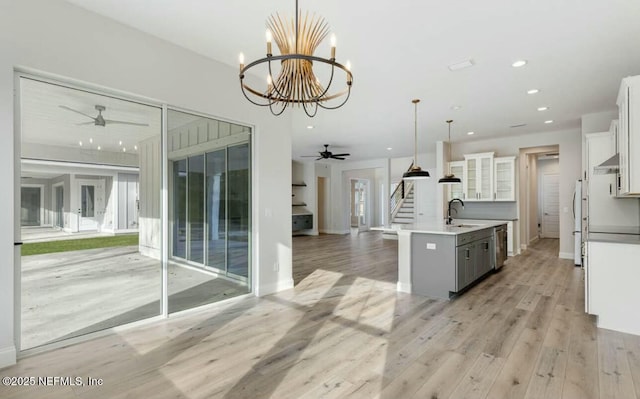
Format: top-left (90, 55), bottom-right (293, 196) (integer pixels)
top-left (376, 221), bottom-right (506, 299)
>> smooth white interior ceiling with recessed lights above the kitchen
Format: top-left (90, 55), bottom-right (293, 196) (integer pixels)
top-left (63, 0), bottom-right (640, 159)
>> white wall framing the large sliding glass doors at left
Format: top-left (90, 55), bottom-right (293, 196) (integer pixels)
top-left (0, 0), bottom-right (293, 367)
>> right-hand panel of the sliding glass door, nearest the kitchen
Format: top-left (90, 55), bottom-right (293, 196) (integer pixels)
top-left (168, 110), bottom-right (251, 312)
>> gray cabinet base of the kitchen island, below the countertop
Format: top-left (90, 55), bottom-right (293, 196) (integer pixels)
top-left (411, 227), bottom-right (495, 299)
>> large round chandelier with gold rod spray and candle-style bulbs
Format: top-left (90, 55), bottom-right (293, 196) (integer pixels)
top-left (240, 0), bottom-right (353, 117)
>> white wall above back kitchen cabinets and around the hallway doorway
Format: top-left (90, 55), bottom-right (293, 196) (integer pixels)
top-left (453, 130), bottom-right (582, 258)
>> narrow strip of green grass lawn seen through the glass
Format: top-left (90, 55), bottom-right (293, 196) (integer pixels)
top-left (22, 234), bottom-right (138, 256)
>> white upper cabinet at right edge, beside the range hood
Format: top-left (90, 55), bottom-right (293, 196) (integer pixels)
top-left (618, 76), bottom-right (640, 196)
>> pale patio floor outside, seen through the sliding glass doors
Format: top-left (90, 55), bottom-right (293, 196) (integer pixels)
top-left (21, 246), bottom-right (248, 350)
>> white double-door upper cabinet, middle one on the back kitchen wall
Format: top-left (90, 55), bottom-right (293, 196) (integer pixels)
top-left (463, 152), bottom-right (494, 201)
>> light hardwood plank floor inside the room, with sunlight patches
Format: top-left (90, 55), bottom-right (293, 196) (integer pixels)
top-left (0, 233), bottom-right (640, 399)
